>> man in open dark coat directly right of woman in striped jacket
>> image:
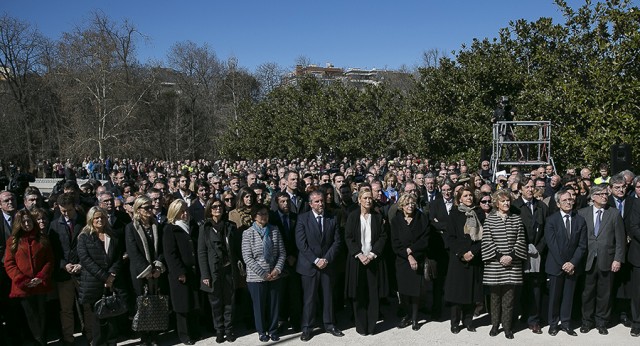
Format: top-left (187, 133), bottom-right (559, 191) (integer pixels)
top-left (513, 178), bottom-right (548, 334)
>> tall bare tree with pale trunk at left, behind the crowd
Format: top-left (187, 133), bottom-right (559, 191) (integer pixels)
top-left (55, 13), bottom-right (154, 157)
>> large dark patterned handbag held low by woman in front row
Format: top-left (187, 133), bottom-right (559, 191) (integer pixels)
top-left (131, 285), bottom-right (169, 332)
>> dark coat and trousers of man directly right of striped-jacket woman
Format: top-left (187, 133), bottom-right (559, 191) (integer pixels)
top-left (512, 197), bottom-right (548, 326)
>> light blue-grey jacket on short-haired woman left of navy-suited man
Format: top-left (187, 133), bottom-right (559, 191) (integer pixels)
top-left (242, 225), bottom-right (287, 282)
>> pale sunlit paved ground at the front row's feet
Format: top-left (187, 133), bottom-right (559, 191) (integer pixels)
top-left (111, 300), bottom-right (640, 346)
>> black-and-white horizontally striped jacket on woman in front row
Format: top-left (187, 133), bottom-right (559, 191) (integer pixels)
top-left (482, 213), bottom-right (527, 286)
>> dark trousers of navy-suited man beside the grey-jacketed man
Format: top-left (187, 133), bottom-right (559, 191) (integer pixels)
top-left (549, 273), bottom-right (578, 328)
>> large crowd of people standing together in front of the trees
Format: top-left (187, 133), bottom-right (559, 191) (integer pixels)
top-left (0, 156), bottom-right (640, 345)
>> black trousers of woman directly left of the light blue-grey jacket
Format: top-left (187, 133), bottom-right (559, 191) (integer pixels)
top-left (208, 266), bottom-right (235, 335)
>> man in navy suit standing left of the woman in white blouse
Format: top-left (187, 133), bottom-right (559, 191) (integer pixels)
top-left (296, 190), bottom-right (344, 341)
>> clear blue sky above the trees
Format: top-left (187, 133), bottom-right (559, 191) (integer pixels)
top-left (0, 0), bottom-right (608, 71)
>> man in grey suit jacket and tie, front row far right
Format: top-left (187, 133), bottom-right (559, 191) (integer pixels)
top-left (578, 185), bottom-right (627, 335)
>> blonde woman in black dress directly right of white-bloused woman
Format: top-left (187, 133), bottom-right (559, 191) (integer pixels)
top-left (391, 194), bottom-right (430, 330)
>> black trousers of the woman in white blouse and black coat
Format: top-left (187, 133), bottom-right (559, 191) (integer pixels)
top-left (353, 264), bottom-right (380, 334)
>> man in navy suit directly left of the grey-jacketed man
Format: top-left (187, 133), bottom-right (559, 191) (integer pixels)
top-left (544, 190), bottom-right (587, 336)
